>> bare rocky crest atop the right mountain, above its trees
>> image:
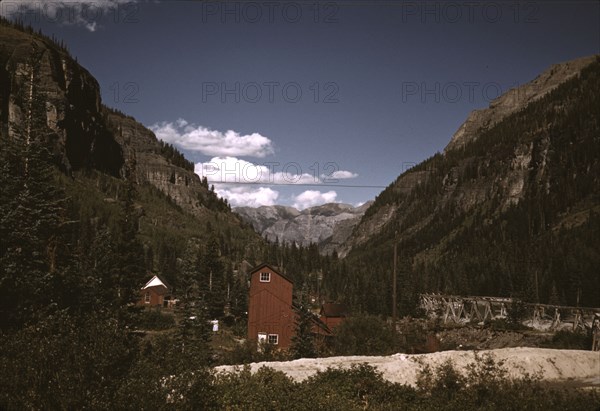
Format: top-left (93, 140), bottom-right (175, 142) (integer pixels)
top-left (444, 56), bottom-right (595, 152)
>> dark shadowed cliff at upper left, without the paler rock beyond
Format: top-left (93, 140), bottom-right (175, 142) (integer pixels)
top-left (0, 25), bottom-right (122, 175)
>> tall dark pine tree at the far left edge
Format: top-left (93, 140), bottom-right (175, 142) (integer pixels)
top-left (0, 43), bottom-right (71, 325)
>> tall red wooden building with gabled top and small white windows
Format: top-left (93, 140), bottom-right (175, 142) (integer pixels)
top-left (248, 264), bottom-right (296, 349)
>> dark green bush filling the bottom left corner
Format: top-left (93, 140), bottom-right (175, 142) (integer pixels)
top-left (0, 311), bottom-right (135, 410)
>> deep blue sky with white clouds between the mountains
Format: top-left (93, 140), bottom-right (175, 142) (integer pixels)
top-left (0, 0), bottom-right (600, 208)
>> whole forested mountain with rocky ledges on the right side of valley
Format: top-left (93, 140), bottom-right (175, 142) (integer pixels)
top-left (339, 56), bottom-right (600, 311)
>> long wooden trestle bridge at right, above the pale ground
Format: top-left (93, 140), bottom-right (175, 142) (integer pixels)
top-left (420, 294), bottom-right (600, 350)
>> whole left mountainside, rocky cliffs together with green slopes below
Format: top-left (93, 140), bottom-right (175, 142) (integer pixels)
top-left (0, 20), bottom-right (264, 285)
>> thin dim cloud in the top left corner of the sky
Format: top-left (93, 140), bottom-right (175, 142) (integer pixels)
top-left (0, 0), bottom-right (138, 32)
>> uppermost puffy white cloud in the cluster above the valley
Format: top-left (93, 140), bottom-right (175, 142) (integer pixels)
top-left (149, 118), bottom-right (274, 157)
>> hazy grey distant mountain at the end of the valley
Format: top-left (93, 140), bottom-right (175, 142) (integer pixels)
top-left (233, 202), bottom-right (371, 254)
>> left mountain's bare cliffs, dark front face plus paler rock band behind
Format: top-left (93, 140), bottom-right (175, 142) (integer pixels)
top-left (0, 25), bottom-right (227, 218)
